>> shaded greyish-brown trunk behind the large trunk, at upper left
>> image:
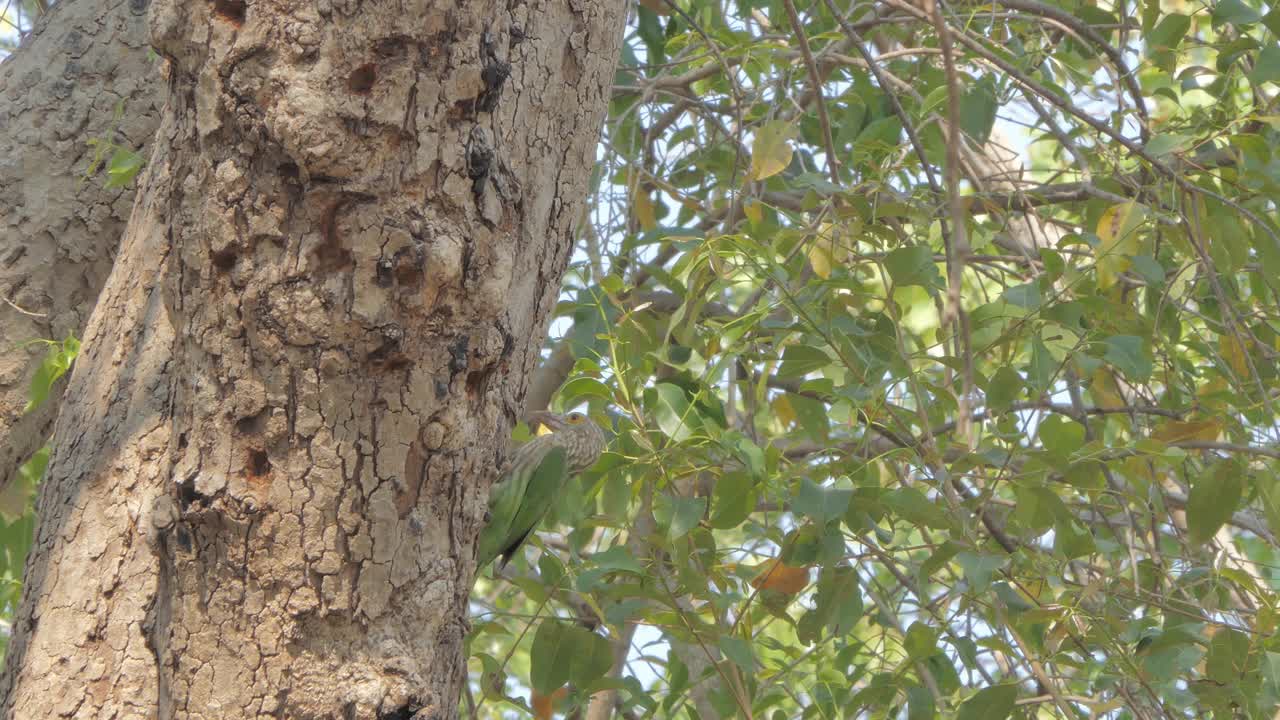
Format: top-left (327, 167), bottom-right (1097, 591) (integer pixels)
top-left (0, 0), bottom-right (163, 488)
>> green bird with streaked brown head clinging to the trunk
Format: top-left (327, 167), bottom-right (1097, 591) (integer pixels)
top-left (476, 413), bottom-right (604, 570)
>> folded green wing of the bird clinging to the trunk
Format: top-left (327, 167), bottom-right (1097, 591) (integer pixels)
top-left (476, 436), bottom-right (564, 568)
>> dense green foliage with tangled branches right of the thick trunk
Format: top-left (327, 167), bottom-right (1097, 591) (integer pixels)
top-left (462, 0), bottom-right (1280, 719)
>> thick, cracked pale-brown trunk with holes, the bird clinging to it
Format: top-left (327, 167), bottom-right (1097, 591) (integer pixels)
top-left (0, 0), bottom-right (623, 719)
